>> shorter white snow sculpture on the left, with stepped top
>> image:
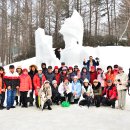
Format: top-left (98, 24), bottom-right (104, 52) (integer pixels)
top-left (35, 28), bottom-right (60, 66)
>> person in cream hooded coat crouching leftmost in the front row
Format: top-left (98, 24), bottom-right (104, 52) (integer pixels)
top-left (40, 80), bottom-right (52, 110)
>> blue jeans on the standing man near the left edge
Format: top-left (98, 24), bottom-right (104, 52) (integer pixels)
top-left (7, 90), bottom-right (16, 108)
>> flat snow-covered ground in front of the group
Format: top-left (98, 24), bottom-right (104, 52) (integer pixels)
top-left (0, 97), bottom-right (130, 130)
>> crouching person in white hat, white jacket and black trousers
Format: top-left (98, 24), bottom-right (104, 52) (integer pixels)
top-left (79, 79), bottom-right (94, 107)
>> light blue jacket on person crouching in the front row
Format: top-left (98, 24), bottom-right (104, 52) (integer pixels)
top-left (72, 81), bottom-right (82, 97)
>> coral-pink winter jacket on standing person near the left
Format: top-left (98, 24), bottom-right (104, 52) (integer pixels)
top-left (19, 74), bottom-right (32, 92)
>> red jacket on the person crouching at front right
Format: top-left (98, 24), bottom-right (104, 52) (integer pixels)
top-left (103, 85), bottom-right (117, 100)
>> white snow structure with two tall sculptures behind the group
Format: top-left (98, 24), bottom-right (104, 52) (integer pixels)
top-left (5, 11), bottom-right (130, 73)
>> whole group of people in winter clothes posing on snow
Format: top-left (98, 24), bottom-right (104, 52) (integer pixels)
top-left (0, 56), bottom-right (130, 110)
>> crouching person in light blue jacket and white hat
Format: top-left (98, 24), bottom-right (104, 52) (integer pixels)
top-left (71, 76), bottom-right (82, 104)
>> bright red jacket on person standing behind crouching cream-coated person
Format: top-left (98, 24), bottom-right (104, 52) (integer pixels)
top-left (33, 74), bottom-right (46, 96)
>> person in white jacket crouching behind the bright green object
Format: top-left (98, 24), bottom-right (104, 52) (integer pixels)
top-left (58, 78), bottom-right (72, 103)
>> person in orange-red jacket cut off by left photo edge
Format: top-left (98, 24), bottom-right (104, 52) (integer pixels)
top-left (0, 66), bottom-right (6, 110)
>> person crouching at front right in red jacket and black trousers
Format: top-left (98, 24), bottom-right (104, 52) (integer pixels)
top-left (102, 80), bottom-right (117, 108)
